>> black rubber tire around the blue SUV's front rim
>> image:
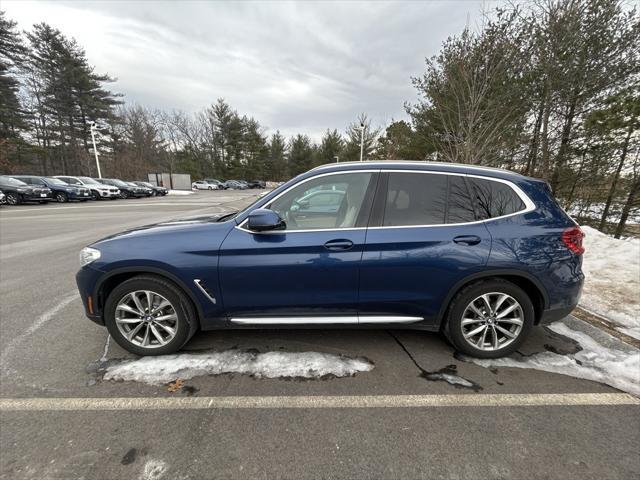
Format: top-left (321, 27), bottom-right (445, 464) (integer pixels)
top-left (104, 275), bottom-right (198, 356)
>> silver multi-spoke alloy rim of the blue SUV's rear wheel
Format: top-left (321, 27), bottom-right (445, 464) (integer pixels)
top-left (461, 292), bottom-right (524, 351)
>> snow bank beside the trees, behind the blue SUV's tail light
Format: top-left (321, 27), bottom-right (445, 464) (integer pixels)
top-left (580, 226), bottom-right (640, 339)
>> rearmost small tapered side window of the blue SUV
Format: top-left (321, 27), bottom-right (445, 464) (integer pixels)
top-left (467, 177), bottom-right (525, 220)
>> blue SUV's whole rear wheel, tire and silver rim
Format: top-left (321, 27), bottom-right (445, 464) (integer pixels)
top-left (444, 279), bottom-right (535, 358)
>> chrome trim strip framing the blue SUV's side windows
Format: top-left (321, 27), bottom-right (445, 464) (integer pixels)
top-left (234, 167), bottom-right (536, 235)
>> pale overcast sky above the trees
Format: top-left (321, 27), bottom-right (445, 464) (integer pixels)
top-left (1, 0), bottom-right (495, 139)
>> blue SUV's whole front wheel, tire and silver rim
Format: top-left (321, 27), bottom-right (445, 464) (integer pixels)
top-left (104, 275), bottom-right (197, 355)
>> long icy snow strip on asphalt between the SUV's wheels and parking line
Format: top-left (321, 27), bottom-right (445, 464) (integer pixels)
top-left (104, 350), bottom-right (373, 385)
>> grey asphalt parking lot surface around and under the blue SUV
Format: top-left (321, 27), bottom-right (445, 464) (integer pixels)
top-left (0, 191), bottom-right (640, 479)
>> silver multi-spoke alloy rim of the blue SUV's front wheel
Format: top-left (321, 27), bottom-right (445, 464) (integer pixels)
top-left (115, 290), bottom-right (178, 348)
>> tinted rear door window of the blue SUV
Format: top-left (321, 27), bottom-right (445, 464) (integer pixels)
top-left (382, 172), bottom-right (447, 227)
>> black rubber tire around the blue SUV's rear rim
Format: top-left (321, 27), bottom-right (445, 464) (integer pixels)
top-left (442, 278), bottom-right (535, 358)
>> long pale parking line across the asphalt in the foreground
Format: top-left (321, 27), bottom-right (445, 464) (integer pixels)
top-left (0, 393), bottom-right (640, 412)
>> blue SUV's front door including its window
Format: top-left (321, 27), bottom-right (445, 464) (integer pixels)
top-left (219, 171), bottom-right (377, 324)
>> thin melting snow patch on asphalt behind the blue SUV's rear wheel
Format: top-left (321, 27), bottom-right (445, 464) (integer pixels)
top-left (467, 320), bottom-right (640, 395)
